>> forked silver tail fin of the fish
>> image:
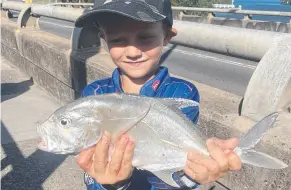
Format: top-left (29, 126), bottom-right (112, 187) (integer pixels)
top-left (235, 112), bottom-right (288, 169)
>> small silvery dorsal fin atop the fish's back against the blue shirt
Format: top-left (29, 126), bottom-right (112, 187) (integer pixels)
top-left (158, 98), bottom-right (199, 110)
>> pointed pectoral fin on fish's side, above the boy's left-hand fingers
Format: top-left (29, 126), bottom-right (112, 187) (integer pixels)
top-left (100, 106), bottom-right (151, 143)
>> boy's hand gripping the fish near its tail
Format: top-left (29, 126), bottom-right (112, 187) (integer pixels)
top-left (184, 138), bottom-right (241, 184)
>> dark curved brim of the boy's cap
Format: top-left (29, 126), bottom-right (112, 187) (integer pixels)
top-left (75, 1), bottom-right (166, 27)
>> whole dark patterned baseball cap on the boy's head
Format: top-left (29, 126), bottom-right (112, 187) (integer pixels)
top-left (75, 0), bottom-right (173, 27)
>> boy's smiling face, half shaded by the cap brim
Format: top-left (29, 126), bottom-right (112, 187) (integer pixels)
top-left (100, 16), bottom-right (175, 79)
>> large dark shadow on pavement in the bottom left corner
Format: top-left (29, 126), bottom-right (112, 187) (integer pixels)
top-left (1, 121), bottom-right (67, 190)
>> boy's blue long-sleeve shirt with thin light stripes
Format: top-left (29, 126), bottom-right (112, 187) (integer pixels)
top-left (82, 67), bottom-right (200, 190)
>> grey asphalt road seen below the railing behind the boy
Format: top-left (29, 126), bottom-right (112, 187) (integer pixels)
top-left (7, 14), bottom-right (257, 96)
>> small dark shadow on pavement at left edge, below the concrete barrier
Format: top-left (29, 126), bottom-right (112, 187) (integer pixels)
top-left (1, 77), bottom-right (34, 102)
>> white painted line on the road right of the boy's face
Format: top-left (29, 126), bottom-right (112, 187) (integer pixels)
top-left (165, 47), bottom-right (256, 70)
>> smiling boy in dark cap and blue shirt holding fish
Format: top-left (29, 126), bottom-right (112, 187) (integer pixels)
top-left (75, 0), bottom-right (241, 190)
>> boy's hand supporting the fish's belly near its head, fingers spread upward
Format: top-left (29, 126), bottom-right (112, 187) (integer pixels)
top-left (77, 133), bottom-right (134, 184)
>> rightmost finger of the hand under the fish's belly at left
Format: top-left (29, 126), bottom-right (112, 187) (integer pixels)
top-left (119, 140), bottom-right (135, 178)
